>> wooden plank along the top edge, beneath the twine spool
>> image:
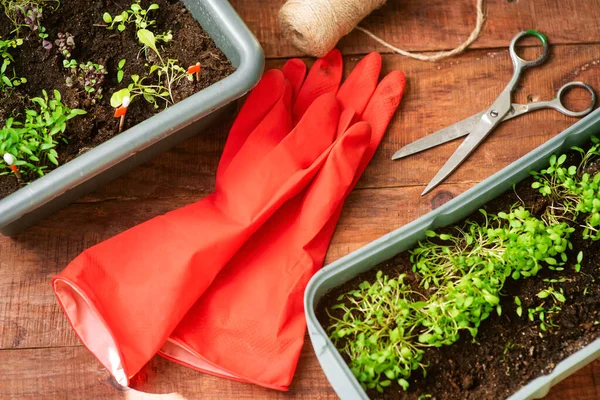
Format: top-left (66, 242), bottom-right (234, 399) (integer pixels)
top-left (231, 0), bottom-right (600, 58)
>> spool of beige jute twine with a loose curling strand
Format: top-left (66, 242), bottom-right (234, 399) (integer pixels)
top-left (279, 0), bottom-right (485, 61)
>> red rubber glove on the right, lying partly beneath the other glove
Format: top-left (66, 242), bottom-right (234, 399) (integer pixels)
top-left (159, 53), bottom-right (405, 390)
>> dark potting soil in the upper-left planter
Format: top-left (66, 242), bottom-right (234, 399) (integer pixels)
top-left (0, 0), bottom-right (235, 199)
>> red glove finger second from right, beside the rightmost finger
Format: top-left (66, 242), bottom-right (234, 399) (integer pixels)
top-left (338, 53), bottom-right (381, 115)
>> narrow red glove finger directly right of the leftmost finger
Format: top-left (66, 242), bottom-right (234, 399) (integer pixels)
top-left (217, 79), bottom-right (292, 186)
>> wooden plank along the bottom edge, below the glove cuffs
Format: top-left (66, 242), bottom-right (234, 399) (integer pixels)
top-left (0, 342), bottom-right (600, 400)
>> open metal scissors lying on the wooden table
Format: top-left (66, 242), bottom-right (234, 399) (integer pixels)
top-left (392, 30), bottom-right (596, 196)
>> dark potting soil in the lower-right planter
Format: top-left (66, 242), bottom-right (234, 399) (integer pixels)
top-left (317, 154), bottom-right (600, 400)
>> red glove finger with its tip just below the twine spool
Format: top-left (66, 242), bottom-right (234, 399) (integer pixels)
top-left (294, 49), bottom-right (343, 124)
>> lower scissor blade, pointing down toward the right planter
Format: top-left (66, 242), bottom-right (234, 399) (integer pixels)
top-left (421, 114), bottom-right (499, 196)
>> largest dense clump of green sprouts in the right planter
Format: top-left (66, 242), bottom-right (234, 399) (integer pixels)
top-left (329, 207), bottom-right (574, 391)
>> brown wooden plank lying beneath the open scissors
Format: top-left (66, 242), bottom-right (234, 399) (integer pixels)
top-left (74, 44), bottom-right (600, 206)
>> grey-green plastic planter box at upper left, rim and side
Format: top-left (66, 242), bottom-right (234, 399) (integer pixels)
top-left (0, 0), bottom-right (264, 235)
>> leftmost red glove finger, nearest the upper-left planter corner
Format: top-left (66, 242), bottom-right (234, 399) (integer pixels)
top-left (217, 70), bottom-right (286, 176)
